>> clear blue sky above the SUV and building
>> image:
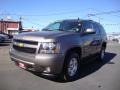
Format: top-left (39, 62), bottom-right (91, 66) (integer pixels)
top-left (0, 0), bottom-right (120, 32)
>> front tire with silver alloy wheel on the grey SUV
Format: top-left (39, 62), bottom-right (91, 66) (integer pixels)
top-left (63, 52), bottom-right (79, 81)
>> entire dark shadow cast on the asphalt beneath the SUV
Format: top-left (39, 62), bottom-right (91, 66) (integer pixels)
top-left (32, 52), bottom-right (117, 83)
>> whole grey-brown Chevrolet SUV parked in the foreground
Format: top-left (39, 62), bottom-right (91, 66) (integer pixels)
top-left (10, 19), bottom-right (107, 80)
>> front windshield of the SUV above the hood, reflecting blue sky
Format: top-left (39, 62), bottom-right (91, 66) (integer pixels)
top-left (42, 21), bottom-right (81, 31)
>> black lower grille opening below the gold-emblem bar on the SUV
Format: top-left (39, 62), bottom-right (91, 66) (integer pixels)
top-left (13, 45), bottom-right (36, 54)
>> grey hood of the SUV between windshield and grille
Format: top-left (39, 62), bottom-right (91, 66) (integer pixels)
top-left (14, 31), bottom-right (75, 41)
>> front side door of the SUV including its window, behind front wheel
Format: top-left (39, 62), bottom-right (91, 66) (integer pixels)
top-left (81, 21), bottom-right (95, 58)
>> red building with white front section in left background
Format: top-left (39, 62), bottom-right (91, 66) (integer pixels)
top-left (0, 19), bottom-right (22, 35)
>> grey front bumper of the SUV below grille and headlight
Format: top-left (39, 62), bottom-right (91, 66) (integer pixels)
top-left (9, 50), bottom-right (64, 74)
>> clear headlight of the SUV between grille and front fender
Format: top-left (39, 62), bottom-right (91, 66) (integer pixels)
top-left (38, 42), bottom-right (60, 54)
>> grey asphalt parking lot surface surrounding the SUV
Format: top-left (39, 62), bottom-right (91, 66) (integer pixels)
top-left (0, 42), bottom-right (120, 90)
